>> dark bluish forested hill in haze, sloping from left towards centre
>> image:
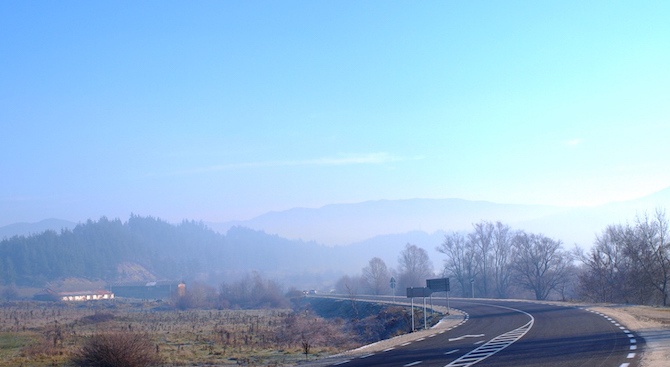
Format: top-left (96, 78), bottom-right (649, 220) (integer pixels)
top-left (0, 215), bottom-right (337, 286)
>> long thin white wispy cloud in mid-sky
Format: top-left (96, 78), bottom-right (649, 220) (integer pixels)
top-left (175, 152), bottom-right (422, 174)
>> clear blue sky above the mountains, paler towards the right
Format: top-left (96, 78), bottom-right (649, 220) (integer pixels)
top-left (0, 0), bottom-right (670, 226)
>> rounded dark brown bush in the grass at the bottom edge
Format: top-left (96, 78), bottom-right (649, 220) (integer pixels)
top-left (72, 332), bottom-right (160, 367)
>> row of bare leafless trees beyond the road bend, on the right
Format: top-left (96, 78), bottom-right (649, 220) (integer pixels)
top-left (335, 210), bottom-right (670, 306)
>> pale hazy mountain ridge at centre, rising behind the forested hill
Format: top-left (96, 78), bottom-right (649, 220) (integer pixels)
top-left (207, 199), bottom-right (565, 246)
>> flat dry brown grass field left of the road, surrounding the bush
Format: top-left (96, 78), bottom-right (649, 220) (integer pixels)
top-left (0, 300), bottom-right (355, 367)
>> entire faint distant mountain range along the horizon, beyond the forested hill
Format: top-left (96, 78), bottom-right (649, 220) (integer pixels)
top-left (0, 188), bottom-right (670, 258)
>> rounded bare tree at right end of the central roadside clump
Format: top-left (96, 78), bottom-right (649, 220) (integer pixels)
top-left (513, 232), bottom-right (570, 300)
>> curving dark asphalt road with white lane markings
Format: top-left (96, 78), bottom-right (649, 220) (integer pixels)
top-left (333, 299), bottom-right (643, 367)
